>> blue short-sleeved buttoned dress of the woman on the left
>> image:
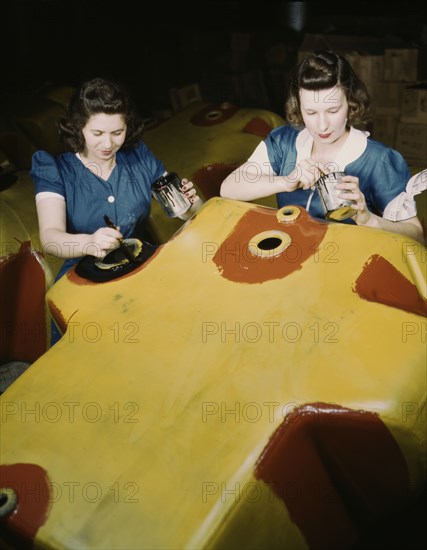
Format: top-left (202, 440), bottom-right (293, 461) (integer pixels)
top-left (30, 142), bottom-right (166, 279)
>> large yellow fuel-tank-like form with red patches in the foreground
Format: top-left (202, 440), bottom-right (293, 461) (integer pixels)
top-left (0, 198), bottom-right (426, 550)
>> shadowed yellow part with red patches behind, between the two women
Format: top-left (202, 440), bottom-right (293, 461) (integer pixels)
top-left (144, 101), bottom-right (285, 242)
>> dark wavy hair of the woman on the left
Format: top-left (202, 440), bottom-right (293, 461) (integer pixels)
top-left (58, 78), bottom-right (144, 153)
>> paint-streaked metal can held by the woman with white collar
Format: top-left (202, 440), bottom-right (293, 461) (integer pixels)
top-left (315, 172), bottom-right (356, 222)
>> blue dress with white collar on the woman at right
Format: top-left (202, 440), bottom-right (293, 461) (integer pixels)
top-left (248, 125), bottom-right (410, 223)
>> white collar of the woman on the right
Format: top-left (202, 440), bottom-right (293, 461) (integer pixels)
top-left (295, 126), bottom-right (369, 172)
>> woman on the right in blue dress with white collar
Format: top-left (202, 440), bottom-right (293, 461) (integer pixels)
top-left (221, 51), bottom-right (423, 241)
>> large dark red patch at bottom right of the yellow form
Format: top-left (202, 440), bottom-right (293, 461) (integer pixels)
top-left (255, 403), bottom-right (410, 550)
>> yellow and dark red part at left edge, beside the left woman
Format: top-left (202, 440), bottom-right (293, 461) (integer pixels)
top-left (0, 172), bottom-right (62, 363)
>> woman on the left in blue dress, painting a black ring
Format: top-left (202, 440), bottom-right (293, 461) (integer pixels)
top-left (30, 78), bottom-right (202, 344)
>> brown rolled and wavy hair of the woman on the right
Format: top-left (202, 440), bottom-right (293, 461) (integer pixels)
top-left (285, 51), bottom-right (372, 130)
